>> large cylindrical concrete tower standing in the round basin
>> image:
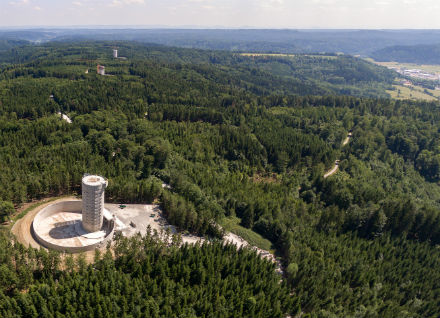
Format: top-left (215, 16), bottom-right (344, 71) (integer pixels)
top-left (82, 176), bottom-right (108, 232)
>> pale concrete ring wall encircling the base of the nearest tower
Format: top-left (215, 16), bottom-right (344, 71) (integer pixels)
top-left (32, 200), bottom-right (115, 253)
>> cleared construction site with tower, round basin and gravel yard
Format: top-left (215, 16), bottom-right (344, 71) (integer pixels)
top-left (12, 175), bottom-right (166, 253)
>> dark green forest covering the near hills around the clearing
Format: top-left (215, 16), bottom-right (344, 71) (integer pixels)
top-left (0, 42), bottom-right (440, 317)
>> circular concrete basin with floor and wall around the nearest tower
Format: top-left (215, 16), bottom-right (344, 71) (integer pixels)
top-left (32, 201), bottom-right (115, 253)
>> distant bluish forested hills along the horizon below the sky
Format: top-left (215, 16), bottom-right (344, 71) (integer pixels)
top-left (4, 27), bottom-right (439, 57)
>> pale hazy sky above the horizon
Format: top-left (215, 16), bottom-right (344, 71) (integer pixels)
top-left (0, 0), bottom-right (440, 28)
